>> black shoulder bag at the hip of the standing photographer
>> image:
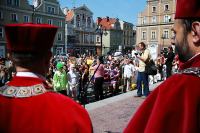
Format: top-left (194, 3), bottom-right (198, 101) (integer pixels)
top-left (145, 58), bottom-right (157, 75)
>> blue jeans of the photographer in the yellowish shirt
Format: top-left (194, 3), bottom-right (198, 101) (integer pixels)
top-left (137, 72), bottom-right (149, 96)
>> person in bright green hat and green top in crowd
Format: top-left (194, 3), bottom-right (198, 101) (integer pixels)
top-left (53, 62), bottom-right (68, 95)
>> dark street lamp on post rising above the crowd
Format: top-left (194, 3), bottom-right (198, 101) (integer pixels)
top-left (96, 25), bottom-right (108, 55)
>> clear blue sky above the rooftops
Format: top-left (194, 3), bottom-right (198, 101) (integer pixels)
top-left (29, 0), bottom-right (146, 25)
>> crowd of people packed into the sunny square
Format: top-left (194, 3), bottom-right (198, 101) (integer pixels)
top-left (0, 43), bottom-right (177, 102)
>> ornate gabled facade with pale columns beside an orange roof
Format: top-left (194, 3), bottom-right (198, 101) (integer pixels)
top-left (64, 5), bottom-right (97, 55)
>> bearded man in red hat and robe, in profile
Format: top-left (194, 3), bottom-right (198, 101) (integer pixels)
top-left (124, 0), bottom-right (200, 133)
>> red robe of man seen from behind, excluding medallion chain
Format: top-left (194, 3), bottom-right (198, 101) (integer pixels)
top-left (0, 77), bottom-right (92, 133)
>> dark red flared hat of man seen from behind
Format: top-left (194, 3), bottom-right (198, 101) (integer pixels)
top-left (5, 23), bottom-right (57, 53)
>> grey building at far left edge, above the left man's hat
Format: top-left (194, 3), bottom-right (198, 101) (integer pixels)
top-left (0, 0), bottom-right (33, 57)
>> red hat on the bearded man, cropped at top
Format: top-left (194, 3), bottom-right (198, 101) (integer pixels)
top-left (175, 0), bottom-right (200, 19)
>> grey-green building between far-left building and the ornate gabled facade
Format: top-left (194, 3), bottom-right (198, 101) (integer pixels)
top-left (33, 0), bottom-right (66, 55)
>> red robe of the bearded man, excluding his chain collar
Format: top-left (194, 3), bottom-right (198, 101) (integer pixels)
top-left (124, 55), bottom-right (200, 133)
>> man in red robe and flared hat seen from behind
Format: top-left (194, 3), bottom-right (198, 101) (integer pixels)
top-left (0, 24), bottom-right (92, 133)
